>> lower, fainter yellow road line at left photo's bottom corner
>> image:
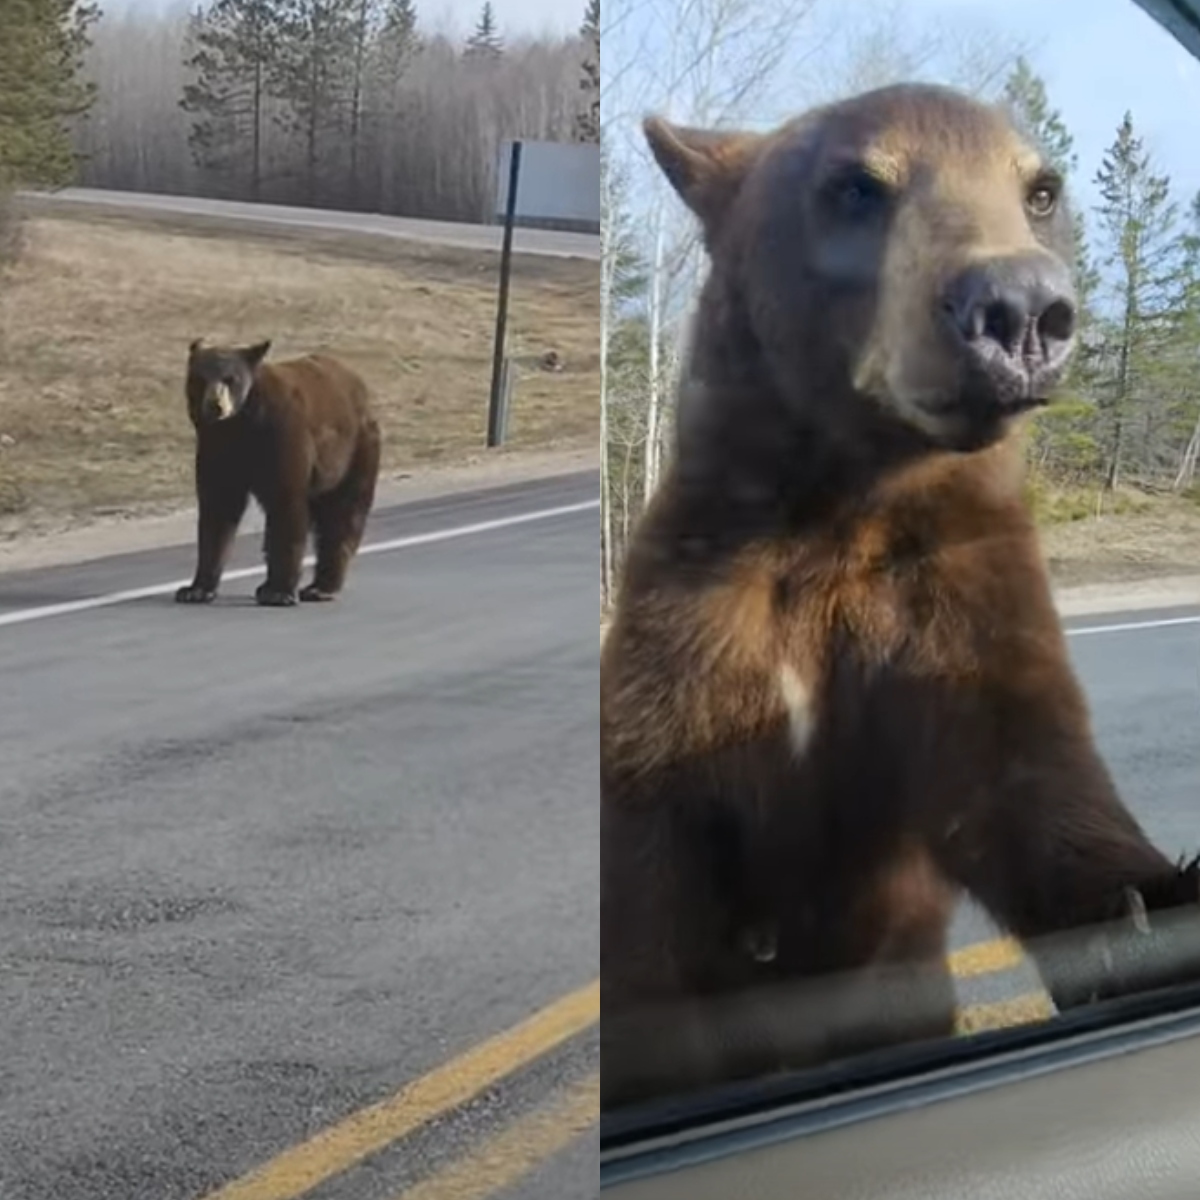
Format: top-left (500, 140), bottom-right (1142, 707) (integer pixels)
top-left (395, 1073), bottom-right (600, 1200)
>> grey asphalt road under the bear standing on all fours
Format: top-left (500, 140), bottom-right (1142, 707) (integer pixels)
top-left (0, 474), bottom-right (599, 1200)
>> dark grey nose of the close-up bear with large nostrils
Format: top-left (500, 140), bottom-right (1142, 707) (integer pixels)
top-left (942, 254), bottom-right (1076, 368)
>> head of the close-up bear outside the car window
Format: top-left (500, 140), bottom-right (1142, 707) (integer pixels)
top-left (644, 84), bottom-right (1076, 451)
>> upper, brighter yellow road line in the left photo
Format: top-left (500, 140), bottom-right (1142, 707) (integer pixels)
top-left (208, 979), bottom-right (609, 1200)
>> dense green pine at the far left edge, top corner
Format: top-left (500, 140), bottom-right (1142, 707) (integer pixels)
top-left (0, 0), bottom-right (100, 187)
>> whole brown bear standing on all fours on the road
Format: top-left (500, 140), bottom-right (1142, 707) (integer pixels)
top-left (175, 341), bottom-right (380, 606)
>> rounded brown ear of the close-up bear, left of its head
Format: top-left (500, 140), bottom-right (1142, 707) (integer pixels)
top-left (642, 116), bottom-right (766, 234)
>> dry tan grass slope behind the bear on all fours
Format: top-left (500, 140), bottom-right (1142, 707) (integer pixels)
top-left (0, 216), bottom-right (599, 533)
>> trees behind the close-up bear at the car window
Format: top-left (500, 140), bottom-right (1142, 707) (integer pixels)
top-left (601, 8), bottom-right (1200, 599)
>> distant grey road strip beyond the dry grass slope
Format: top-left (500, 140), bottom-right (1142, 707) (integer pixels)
top-left (16, 187), bottom-right (600, 259)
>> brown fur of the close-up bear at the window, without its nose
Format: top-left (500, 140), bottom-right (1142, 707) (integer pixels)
top-left (600, 86), bottom-right (1200, 1106)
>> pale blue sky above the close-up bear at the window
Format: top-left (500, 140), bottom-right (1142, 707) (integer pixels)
top-left (601, 0), bottom-right (1200, 238)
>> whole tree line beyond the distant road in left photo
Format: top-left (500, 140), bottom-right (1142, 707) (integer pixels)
top-left (0, 0), bottom-right (600, 221)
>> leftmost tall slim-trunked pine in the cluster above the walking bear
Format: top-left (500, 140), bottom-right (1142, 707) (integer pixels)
top-left (180, 0), bottom-right (284, 200)
